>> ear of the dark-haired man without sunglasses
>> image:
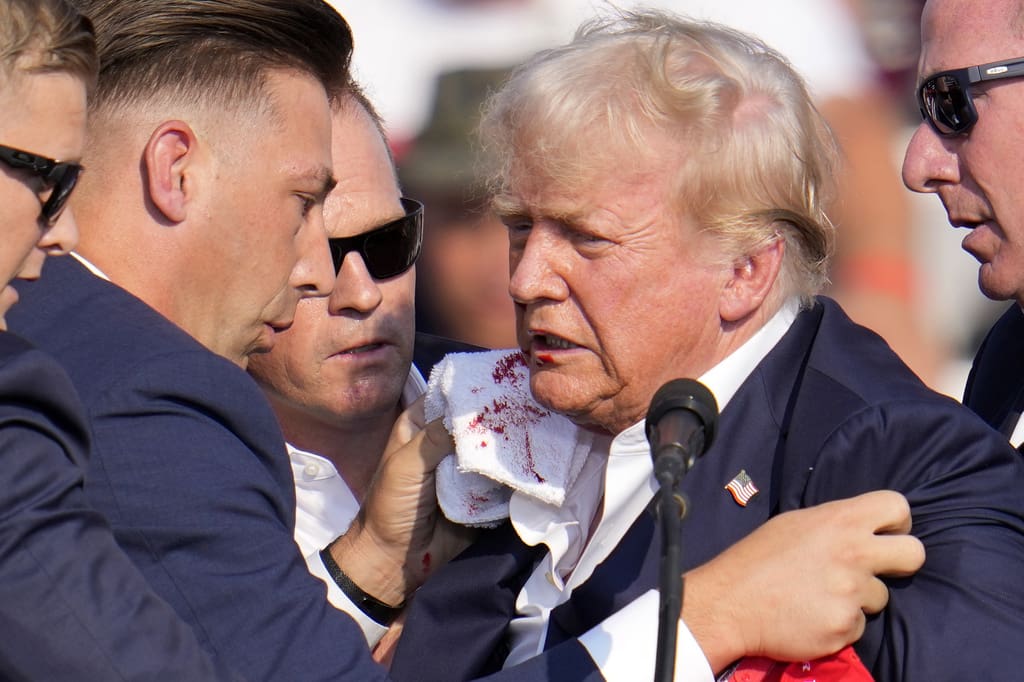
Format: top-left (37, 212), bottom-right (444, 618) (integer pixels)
top-left (143, 121), bottom-right (199, 223)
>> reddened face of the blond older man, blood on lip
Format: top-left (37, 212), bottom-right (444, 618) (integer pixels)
top-left (500, 155), bottom-right (729, 433)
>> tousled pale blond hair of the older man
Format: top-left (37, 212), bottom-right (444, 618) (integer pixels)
top-left (481, 10), bottom-right (838, 301)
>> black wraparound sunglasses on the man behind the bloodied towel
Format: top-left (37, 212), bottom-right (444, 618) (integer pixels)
top-left (328, 197), bottom-right (423, 280)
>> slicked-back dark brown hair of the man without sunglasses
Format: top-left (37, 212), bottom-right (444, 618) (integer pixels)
top-left (73, 0), bottom-right (352, 111)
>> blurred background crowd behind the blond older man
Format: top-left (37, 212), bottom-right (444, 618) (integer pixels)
top-left (331, 0), bottom-right (1005, 397)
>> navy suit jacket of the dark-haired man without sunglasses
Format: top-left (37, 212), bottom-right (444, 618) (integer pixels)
top-left (9, 258), bottom-right (384, 682)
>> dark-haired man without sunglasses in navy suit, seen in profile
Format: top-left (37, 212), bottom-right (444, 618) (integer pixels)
top-left (11, 0), bottom-right (449, 680)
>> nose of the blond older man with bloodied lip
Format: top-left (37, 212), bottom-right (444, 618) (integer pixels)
top-left (509, 224), bottom-right (571, 304)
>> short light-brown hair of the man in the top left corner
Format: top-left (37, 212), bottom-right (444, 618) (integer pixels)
top-left (0, 0), bottom-right (97, 88)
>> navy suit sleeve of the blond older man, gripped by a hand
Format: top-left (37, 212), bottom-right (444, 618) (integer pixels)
top-left (806, 401), bottom-right (1024, 682)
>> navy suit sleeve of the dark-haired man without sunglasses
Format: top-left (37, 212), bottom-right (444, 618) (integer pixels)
top-left (81, 352), bottom-right (385, 681)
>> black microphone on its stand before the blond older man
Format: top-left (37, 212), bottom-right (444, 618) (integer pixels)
top-left (647, 379), bottom-right (718, 682)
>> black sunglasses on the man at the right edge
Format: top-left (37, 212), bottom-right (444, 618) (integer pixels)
top-left (918, 57), bottom-right (1024, 136)
